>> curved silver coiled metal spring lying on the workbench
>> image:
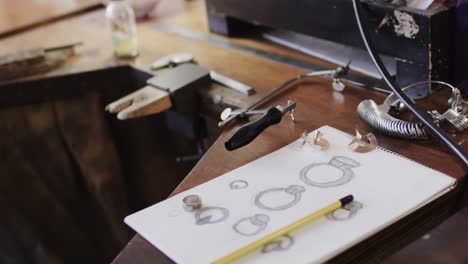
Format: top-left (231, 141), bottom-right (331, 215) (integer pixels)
top-left (357, 100), bottom-right (428, 139)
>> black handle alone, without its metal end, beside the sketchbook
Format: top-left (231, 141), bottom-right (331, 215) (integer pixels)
top-left (224, 107), bottom-right (283, 151)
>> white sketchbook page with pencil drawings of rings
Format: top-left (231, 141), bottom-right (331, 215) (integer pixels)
top-left (125, 126), bottom-right (455, 264)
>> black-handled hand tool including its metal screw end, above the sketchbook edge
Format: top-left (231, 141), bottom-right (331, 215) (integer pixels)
top-left (224, 100), bottom-right (296, 151)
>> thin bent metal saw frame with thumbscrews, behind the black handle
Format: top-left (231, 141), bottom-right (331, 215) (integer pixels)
top-left (218, 62), bottom-right (351, 127)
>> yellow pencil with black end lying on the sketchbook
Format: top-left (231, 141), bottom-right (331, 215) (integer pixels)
top-left (213, 195), bottom-right (354, 264)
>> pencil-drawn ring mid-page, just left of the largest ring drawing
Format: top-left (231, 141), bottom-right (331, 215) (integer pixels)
top-left (255, 185), bottom-right (305, 211)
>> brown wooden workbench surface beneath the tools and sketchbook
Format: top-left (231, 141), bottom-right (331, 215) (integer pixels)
top-left (0, 1), bottom-right (466, 263)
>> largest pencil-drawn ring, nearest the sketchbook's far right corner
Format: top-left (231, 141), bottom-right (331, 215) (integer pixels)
top-left (299, 156), bottom-right (361, 188)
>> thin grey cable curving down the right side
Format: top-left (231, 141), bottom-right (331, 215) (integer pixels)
top-left (353, 0), bottom-right (468, 169)
